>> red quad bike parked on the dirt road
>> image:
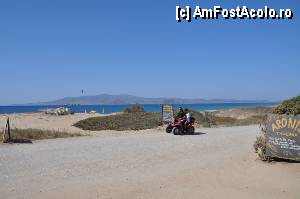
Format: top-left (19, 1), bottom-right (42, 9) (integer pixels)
top-left (166, 117), bottom-right (195, 135)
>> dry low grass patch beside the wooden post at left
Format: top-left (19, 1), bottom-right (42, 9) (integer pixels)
top-left (0, 128), bottom-right (81, 142)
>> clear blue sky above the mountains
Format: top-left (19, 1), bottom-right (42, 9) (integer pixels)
top-left (0, 0), bottom-right (300, 105)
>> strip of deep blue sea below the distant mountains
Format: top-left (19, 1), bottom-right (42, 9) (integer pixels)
top-left (0, 102), bottom-right (278, 114)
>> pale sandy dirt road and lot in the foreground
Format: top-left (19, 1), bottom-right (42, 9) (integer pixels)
top-left (0, 126), bottom-right (300, 199)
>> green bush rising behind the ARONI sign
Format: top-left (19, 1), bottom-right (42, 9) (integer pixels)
top-left (274, 95), bottom-right (300, 115)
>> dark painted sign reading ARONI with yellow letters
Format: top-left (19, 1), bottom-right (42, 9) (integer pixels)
top-left (266, 115), bottom-right (300, 161)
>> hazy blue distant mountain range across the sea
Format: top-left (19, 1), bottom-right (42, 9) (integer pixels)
top-left (26, 94), bottom-right (268, 105)
